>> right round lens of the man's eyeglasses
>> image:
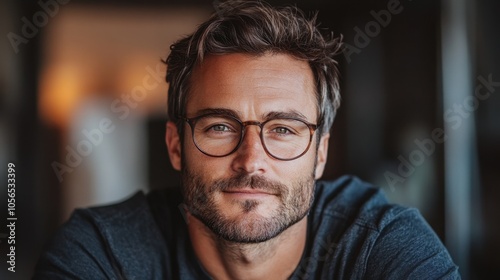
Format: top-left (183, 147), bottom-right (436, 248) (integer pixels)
top-left (262, 119), bottom-right (311, 159)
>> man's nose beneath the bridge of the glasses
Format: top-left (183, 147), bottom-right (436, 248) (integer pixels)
top-left (232, 125), bottom-right (269, 175)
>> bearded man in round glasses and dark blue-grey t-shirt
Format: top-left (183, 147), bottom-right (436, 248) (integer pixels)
top-left (35, 1), bottom-right (460, 279)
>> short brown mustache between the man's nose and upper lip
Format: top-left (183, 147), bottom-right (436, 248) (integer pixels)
top-left (209, 174), bottom-right (288, 195)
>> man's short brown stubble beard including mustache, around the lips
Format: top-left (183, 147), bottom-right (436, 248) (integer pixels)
top-left (182, 168), bottom-right (314, 243)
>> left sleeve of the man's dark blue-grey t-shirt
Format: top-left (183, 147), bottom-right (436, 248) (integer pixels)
top-left (32, 210), bottom-right (123, 279)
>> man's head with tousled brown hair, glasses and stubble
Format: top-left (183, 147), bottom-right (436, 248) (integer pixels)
top-left (166, 1), bottom-right (340, 242)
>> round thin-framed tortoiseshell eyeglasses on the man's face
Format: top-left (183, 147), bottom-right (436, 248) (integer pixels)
top-left (182, 113), bottom-right (318, 160)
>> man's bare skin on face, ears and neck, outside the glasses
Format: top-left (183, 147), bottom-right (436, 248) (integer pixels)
top-left (166, 54), bottom-right (329, 279)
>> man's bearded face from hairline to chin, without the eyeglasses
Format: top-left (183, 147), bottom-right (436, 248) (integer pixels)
top-left (167, 54), bottom-right (328, 243)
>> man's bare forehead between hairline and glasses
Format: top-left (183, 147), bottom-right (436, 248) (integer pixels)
top-left (186, 53), bottom-right (317, 121)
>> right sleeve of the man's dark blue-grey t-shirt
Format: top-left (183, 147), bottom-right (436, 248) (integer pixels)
top-left (366, 209), bottom-right (461, 279)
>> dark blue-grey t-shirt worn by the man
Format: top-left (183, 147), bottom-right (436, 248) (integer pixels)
top-left (33, 176), bottom-right (460, 280)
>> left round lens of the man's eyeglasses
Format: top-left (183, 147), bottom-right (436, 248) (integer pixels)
top-left (193, 115), bottom-right (241, 156)
